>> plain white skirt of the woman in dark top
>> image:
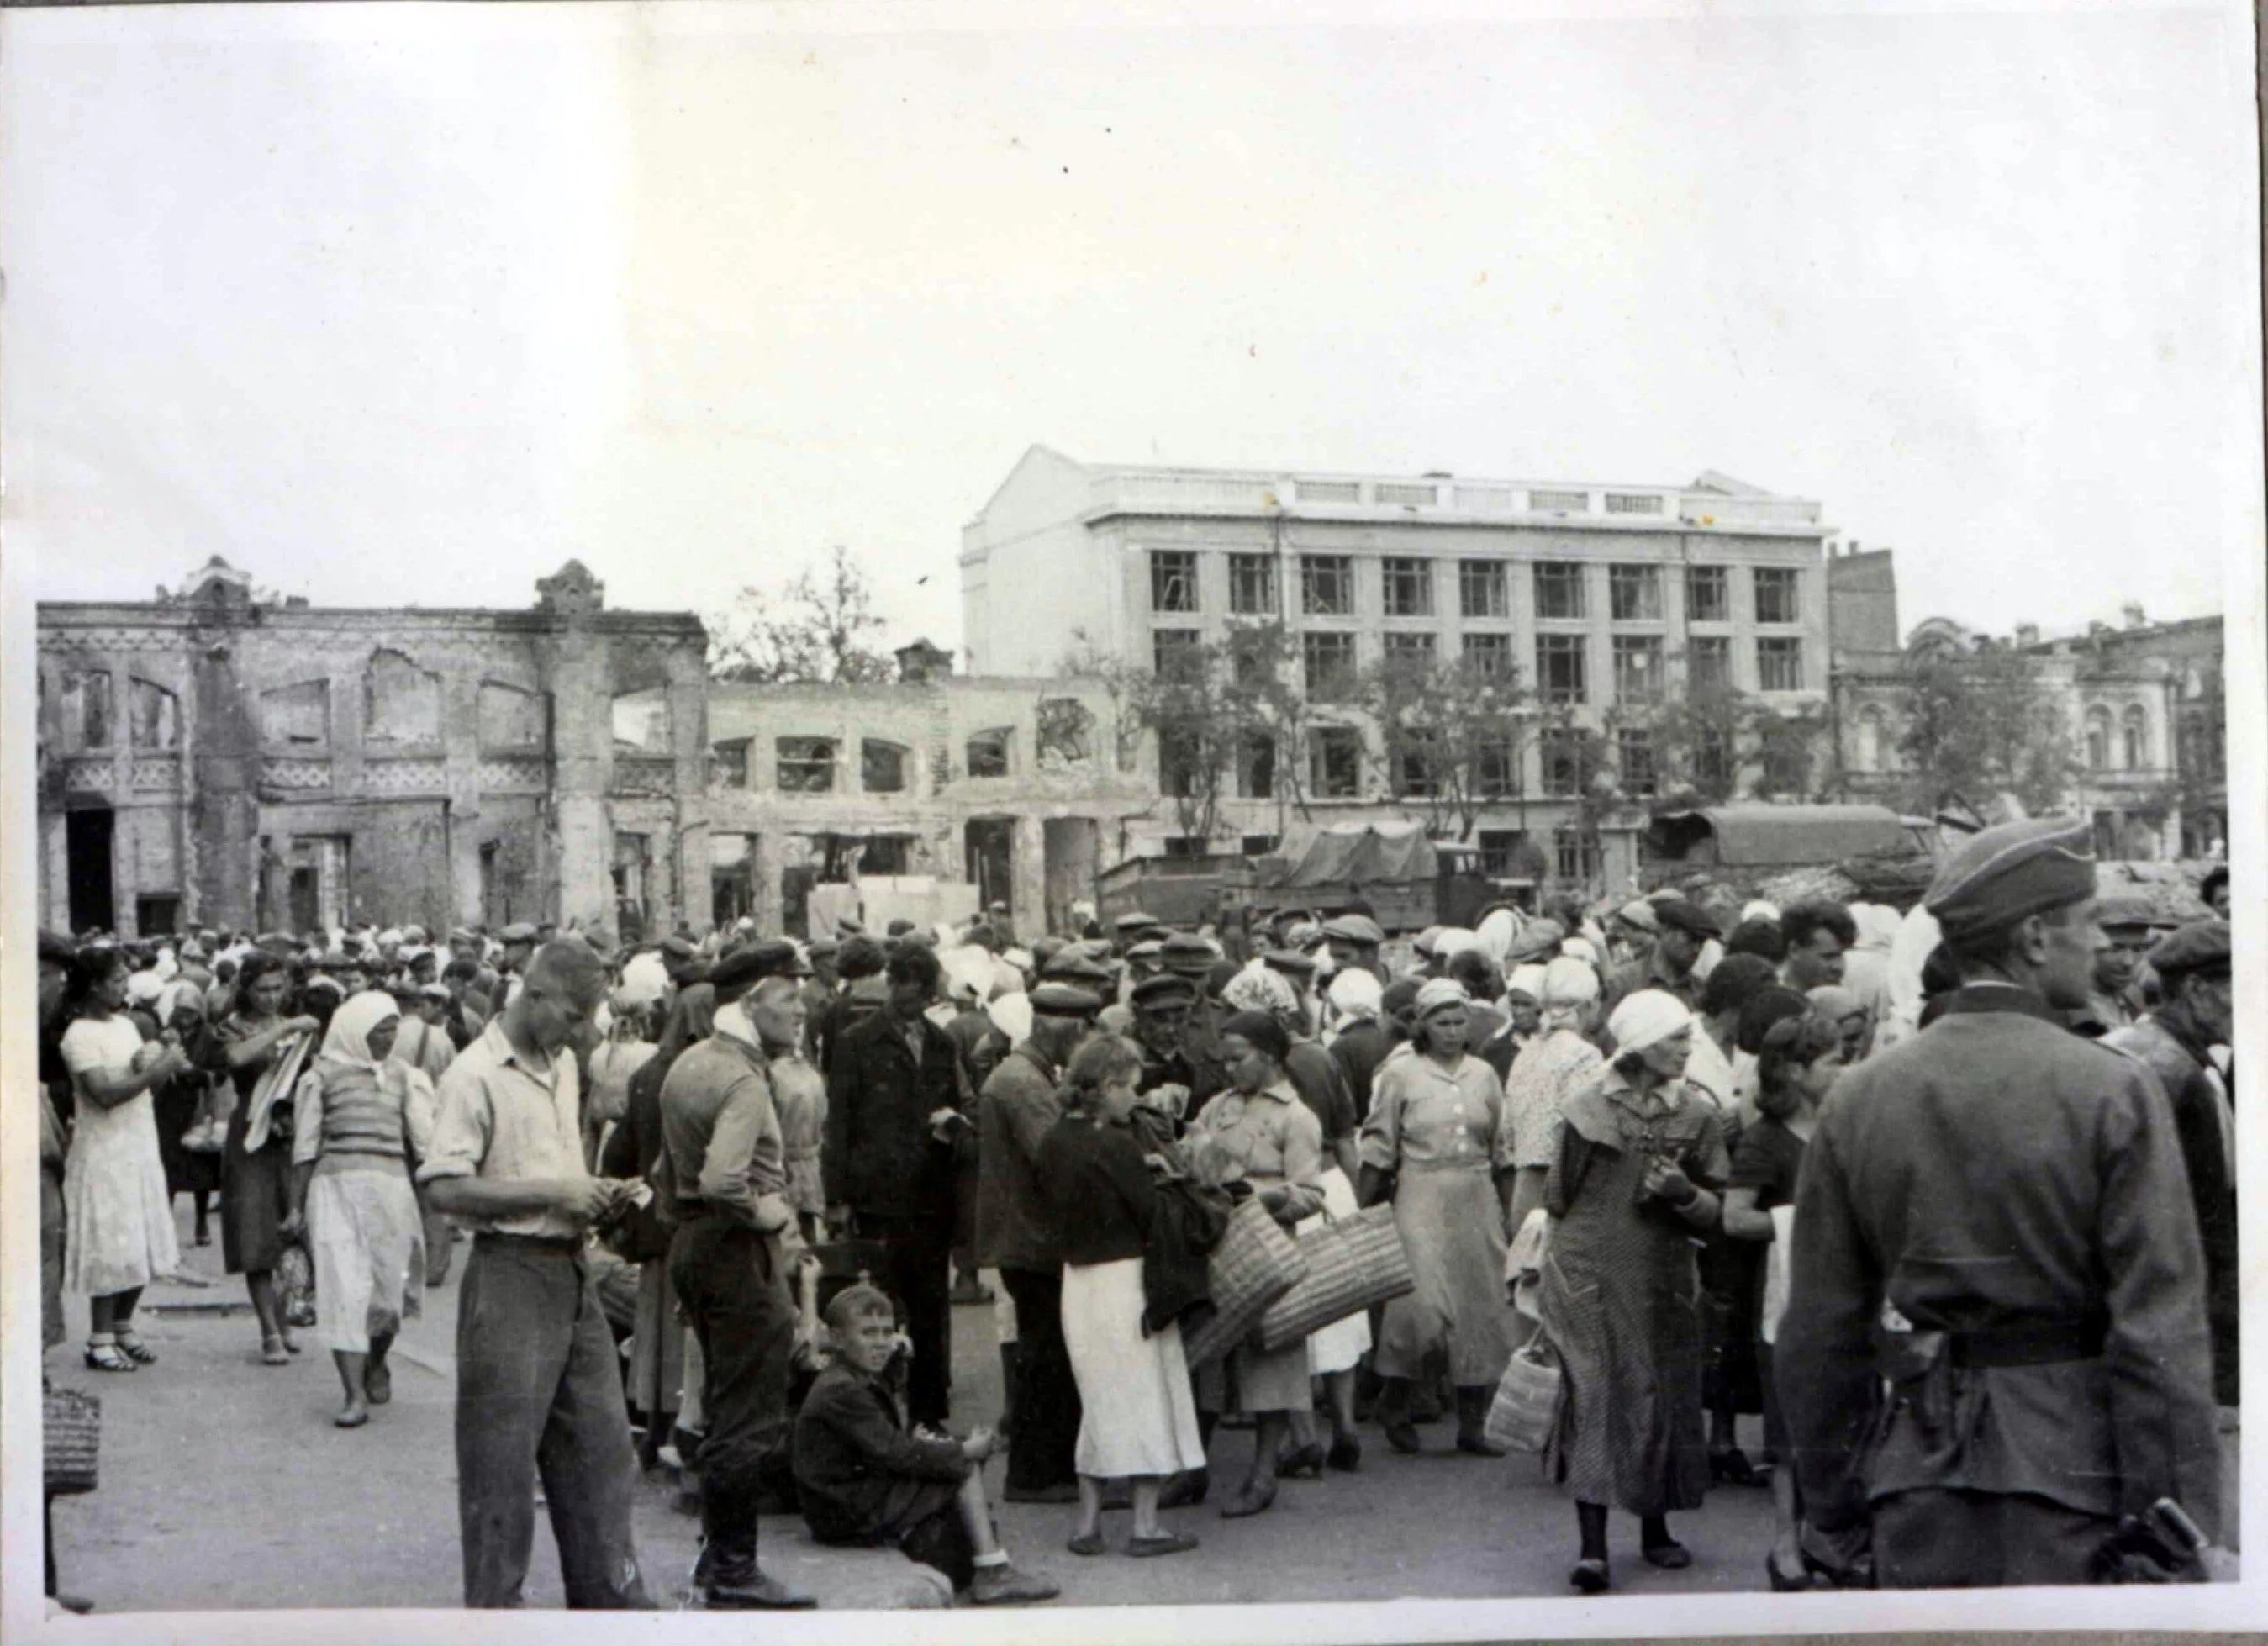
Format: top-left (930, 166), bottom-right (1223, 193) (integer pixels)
top-left (1063, 1258), bottom-right (1205, 1480)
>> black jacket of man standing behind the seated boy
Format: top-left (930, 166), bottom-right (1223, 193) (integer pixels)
top-left (819, 1009), bottom-right (971, 1217)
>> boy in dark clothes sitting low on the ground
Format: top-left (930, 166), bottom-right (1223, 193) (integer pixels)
top-left (796, 1285), bottom-right (1059, 1605)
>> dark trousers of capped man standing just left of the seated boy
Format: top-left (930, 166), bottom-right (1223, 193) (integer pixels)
top-left (669, 1211), bottom-right (796, 1585)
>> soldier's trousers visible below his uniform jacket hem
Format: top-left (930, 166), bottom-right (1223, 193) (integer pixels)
top-left (1874, 1487), bottom-right (2118, 1590)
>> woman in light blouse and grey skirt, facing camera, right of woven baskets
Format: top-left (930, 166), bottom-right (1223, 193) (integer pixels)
top-left (1361, 977), bottom-right (1513, 1458)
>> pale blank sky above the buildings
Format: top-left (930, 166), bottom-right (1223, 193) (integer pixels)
top-left (0, 4), bottom-right (2261, 644)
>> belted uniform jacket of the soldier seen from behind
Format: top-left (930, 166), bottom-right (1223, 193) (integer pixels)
top-left (1774, 986), bottom-right (2218, 1533)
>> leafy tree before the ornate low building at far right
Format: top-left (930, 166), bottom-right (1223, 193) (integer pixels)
top-left (1898, 641), bottom-right (2077, 812)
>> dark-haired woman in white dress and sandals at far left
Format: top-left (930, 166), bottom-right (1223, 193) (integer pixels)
top-left (61, 947), bottom-right (188, 1372)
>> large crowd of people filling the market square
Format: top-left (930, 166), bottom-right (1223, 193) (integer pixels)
top-left (41, 843), bottom-right (2236, 1607)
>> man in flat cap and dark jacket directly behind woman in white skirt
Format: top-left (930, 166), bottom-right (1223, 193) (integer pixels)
top-left (978, 982), bottom-right (1102, 1503)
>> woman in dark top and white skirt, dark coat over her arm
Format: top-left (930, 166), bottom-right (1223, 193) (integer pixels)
top-left (1039, 1037), bottom-right (1205, 1555)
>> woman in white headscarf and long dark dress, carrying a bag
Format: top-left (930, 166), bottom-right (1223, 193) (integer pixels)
top-left (1537, 989), bottom-right (1731, 1594)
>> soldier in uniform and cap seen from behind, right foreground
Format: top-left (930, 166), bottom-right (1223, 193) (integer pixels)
top-left (1774, 819), bottom-right (2218, 1590)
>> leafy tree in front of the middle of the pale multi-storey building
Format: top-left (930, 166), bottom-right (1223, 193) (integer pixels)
top-left (1356, 657), bottom-right (1540, 841)
